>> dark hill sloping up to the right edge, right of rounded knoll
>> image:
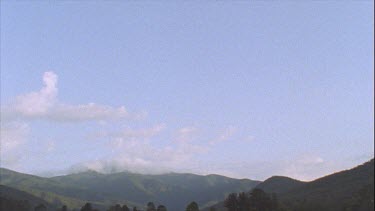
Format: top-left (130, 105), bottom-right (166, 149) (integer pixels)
top-left (280, 159), bottom-right (374, 210)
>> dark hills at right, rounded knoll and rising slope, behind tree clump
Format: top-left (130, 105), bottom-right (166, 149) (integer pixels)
top-left (204, 159), bottom-right (374, 211)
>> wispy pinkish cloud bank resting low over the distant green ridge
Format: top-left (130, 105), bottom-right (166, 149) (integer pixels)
top-left (72, 124), bottom-right (208, 174)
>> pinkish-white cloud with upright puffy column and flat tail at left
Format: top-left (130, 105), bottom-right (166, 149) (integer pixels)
top-left (1, 72), bottom-right (140, 122)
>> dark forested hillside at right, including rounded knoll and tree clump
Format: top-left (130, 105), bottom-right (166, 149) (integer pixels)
top-left (209, 159), bottom-right (374, 211)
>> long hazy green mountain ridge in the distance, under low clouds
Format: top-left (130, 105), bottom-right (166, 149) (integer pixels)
top-left (0, 169), bottom-right (260, 210)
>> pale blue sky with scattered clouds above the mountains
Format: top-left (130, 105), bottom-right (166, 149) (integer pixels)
top-left (0, 1), bottom-right (374, 180)
